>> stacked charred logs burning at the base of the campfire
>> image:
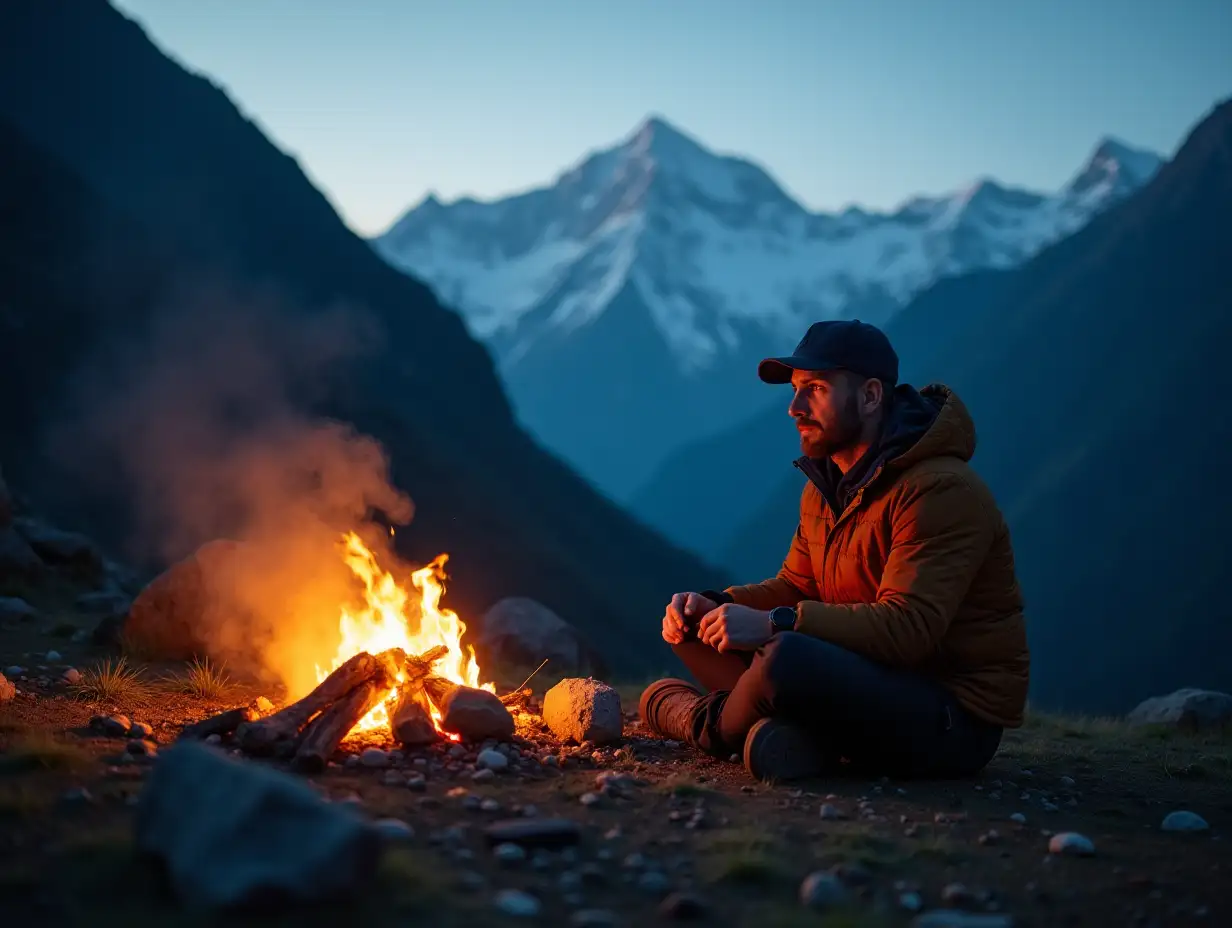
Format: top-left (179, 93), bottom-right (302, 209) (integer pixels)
top-left (180, 647), bottom-right (514, 773)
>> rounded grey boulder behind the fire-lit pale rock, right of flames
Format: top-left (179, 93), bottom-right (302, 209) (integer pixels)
top-left (479, 596), bottom-right (593, 673)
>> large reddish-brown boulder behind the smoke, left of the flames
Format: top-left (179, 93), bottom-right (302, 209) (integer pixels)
top-left (121, 540), bottom-right (243, 661)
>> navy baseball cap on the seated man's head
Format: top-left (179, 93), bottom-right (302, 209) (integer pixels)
top-left (758, 319), bottom-right (898, 387)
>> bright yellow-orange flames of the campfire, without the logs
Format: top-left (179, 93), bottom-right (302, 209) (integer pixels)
top-left (315, 532), bottom-right (496, 741)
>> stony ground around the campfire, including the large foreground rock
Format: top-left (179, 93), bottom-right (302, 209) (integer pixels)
top-left (0, 571), bottom-right (1232, 928)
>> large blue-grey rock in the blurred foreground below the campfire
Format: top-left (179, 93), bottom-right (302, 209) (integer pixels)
top-left (137, 741), bottom-right (383, 908)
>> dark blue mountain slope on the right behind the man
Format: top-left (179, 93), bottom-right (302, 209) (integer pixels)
top-left (714, 101), bottom-right (1232, 711)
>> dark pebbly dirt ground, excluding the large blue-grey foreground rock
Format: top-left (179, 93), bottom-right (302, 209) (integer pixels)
top-left (0, 611), bottom-right (1232, 928)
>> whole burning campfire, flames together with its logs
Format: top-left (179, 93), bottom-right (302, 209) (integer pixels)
top-left (185, 532), bottom-right (514, 771)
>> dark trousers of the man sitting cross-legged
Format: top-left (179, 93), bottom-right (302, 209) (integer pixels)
top-left (673, 632), bottom-right (1002, 778)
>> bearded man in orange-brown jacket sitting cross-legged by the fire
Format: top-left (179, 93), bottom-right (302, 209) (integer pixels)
top-left (639, 320), bottom-right (1029, 780)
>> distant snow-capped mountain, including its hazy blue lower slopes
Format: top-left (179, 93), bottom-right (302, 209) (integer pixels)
top-left (373, 117), bottom-right (1161, 502)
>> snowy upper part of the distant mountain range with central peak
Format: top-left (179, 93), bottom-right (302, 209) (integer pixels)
top-left (375, 116), bottom-right (1162, 370)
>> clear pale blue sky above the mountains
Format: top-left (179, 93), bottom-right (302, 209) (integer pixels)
top-left (113, 0), bottom-right (1232, 234)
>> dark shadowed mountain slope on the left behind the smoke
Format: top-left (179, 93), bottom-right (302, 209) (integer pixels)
top-left (0, 0), bottom-right (723, 673)
